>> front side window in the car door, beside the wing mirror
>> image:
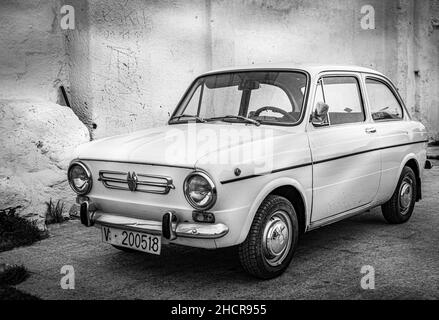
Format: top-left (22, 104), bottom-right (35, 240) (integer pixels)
top-left (323, 76), bottom-right (366, 125)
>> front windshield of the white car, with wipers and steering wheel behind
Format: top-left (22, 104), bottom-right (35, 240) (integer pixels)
top-left (169, 71), bottom-right (307, 125)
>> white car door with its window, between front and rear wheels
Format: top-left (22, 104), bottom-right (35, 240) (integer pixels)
top-left (308, 73), bottom-right (381, 223)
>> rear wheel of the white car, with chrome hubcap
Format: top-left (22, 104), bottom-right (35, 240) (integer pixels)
top-left (381, 167), bottom-right (418, 224)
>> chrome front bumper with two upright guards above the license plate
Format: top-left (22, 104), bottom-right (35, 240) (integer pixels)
top-left (80, 201), bottom-right (229, 240)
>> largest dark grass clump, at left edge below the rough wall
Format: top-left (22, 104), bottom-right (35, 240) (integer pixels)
top-left (0, 206), bottom-right (47, 252)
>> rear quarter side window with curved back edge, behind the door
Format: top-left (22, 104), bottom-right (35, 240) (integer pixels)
top-left (366, 79), bottom-right (403, 120)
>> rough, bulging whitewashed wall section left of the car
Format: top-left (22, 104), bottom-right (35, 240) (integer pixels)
top-left (0, 0), bottom-right (90, 219)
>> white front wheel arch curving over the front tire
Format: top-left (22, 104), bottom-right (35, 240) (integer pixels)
top-left (238, 177), bottom-right (310, 243)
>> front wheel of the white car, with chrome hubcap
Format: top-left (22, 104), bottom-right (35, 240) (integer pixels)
top-left (238, 195), bottom-right (299, 279)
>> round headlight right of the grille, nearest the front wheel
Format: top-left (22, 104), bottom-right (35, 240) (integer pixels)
top-left (184, 172), bottom-right (216, 210)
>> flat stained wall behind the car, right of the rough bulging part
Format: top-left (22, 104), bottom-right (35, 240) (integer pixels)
top-left (62, 0), bottom-right (439, 138)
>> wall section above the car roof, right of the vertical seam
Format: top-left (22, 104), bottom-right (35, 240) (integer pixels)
top-left (210, 0), bottom-right (439, 140)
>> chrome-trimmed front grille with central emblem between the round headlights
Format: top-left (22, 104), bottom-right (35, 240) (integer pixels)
top-left (98, 170), bottom-right (175, 194)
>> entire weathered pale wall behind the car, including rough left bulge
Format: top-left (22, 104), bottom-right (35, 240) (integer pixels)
top-left (0, 0), bottom-right (439, 220)
